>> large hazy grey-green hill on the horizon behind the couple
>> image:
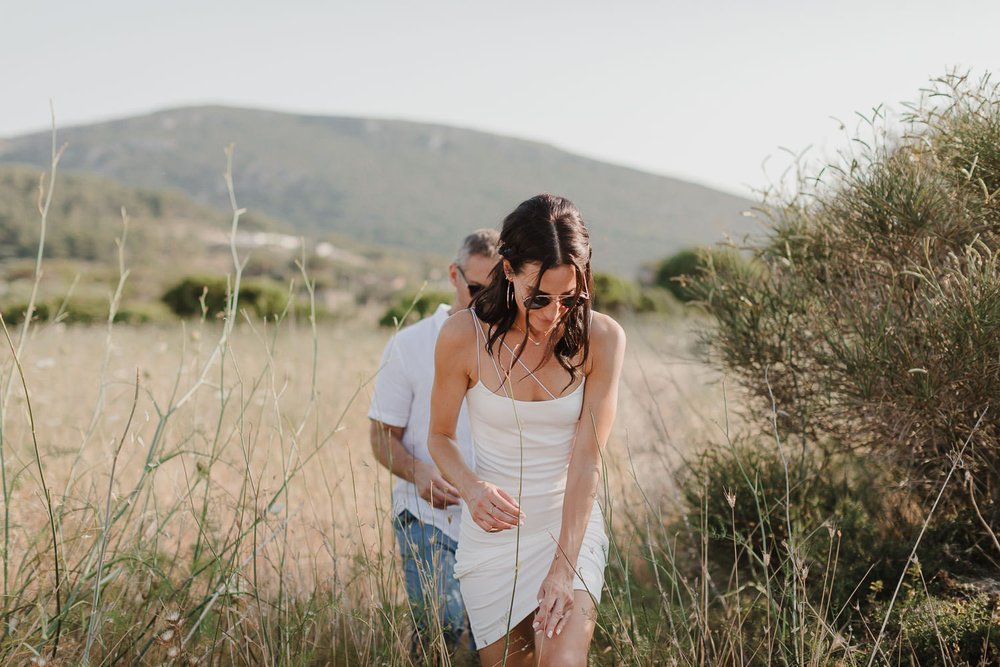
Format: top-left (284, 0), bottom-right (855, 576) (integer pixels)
top-left (0, 107), bottom-right (751, 274)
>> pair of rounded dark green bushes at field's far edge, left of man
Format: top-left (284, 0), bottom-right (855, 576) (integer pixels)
top-left (163, 276), bottom-right (289, 317)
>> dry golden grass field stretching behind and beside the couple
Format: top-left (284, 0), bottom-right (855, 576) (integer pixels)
top-left (0, 310), bottom-right (726, 664)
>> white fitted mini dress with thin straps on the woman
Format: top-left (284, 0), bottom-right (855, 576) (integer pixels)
top-left (455, 312), bottom-right (608, 648)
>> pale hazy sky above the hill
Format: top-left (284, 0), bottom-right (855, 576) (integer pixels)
top-left (0, 0), bottom-right (1000, 195)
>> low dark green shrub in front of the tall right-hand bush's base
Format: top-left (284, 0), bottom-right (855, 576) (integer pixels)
top-left (679, 441), bottom-right (909, 607)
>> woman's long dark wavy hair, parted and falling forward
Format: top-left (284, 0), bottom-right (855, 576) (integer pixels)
top-left (472, 194), bottom-right (593, 387)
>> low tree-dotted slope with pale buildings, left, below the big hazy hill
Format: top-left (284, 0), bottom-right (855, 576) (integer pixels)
top-left (0, 164), bottom-right (446, 312)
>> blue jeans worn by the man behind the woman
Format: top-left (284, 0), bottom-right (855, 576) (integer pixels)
top-left (392, 510), bottom-right (466, 650)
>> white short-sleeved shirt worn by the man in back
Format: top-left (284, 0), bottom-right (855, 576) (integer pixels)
top-left (368, 304), bottom-right (475, 540)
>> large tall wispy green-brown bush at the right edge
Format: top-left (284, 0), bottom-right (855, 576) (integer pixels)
top-left (692, 76), bottom-right (1000, 567)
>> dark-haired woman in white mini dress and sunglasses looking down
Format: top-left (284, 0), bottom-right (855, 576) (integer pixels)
top-left (428, 194), bottom-right (625, 665)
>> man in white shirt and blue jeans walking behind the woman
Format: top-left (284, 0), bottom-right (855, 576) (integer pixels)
top-left (368, 229), bottom-right (499, 652)
